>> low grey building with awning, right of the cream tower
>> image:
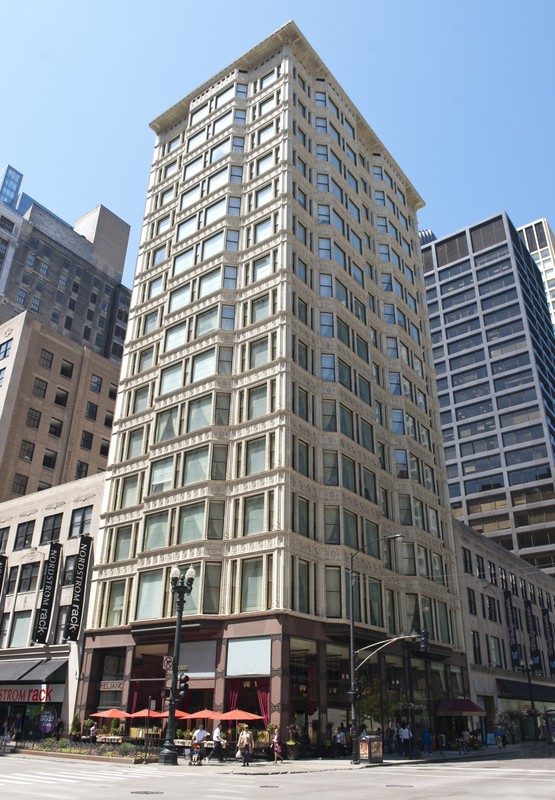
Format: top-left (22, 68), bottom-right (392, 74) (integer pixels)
top-left (455, 521), bottom-right (555, 741)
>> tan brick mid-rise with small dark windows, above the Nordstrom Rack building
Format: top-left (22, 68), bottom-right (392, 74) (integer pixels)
top-left (0, 311), bottom-right (119, 501)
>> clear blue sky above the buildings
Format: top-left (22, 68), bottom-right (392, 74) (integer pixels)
top-left (0, 0), bottom-right (555, 284)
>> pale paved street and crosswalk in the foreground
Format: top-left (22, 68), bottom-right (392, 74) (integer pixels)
top-left (0, 756), bottom-right (554, 800)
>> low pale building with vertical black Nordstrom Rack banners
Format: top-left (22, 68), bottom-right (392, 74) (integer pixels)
top-left (0, 474), bottom-right (104, 738)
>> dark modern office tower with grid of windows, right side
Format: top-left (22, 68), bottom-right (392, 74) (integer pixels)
top-left (422, 213), bottom-right (555, 573)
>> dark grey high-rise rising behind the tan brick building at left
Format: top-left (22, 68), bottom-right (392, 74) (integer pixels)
top-left (0, 172), bottom-right (131, 364)
